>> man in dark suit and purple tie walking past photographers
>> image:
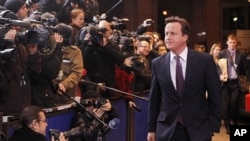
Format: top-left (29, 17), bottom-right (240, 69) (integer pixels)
top-left (147, 17), bottom-right (221, 141)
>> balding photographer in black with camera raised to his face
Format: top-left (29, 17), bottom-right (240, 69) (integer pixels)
top-left (79, 20), bottom-right (135, 107)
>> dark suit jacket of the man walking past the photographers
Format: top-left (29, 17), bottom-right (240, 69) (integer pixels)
top-left (148, 49), bottom-right (222, 141)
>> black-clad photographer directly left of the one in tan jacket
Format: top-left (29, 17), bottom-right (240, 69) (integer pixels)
top-left (30, 27), bottom-right (63, 108)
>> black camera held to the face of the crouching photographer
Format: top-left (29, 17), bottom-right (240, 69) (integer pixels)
top-left (81, 98), bottom-right (108, 108)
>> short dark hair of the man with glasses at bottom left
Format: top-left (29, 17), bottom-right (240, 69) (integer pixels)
top-left (19, 106), bottom-right (45, 127)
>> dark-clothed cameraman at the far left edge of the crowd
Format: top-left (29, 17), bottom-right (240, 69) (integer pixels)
top-left (0, 12), bottom-right (41, 115)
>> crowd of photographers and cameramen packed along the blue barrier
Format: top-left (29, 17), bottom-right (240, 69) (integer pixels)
top-left (0, 0), bottom-right (167, 141)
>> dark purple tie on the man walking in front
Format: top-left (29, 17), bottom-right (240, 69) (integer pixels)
top-left (175, 55), bottom-right (184, 97)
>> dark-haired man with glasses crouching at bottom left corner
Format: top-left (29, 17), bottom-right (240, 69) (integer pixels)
top-left (9, 106), bottom-right (66, 141)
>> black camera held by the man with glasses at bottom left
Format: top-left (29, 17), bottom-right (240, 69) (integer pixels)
top-left (49, 127), bottom-right (82, 141)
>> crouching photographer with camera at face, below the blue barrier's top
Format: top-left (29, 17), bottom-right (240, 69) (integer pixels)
top-left (70, 90), bottom-right (118, 141)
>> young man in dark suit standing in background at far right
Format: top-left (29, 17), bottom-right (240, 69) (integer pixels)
top-left (219, 34), bottom-right (245, 134)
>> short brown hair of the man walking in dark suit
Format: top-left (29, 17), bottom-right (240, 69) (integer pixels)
top-left (165, 16), bottom-right (191, 36)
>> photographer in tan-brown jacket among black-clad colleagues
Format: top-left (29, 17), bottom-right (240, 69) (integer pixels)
top-left (54, 23), bottom-right (83, 104)
